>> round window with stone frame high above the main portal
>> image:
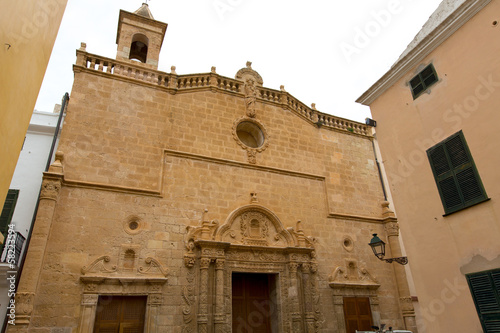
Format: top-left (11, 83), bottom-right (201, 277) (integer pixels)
top-left (233, 117), bottom-right (270, 153)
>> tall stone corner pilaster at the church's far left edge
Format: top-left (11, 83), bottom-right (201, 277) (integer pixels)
top-left (9, 153), bottom-right (63, 331)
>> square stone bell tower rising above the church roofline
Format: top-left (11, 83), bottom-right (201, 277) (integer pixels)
top-left (116, 3), bottom-right (167, 69)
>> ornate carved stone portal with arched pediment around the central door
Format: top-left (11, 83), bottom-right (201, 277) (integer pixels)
top-left (183, 203), bottom-right (320, 333)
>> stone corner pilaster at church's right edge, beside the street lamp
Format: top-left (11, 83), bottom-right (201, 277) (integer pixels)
top-left (385, 221), bottom-right (418, 333)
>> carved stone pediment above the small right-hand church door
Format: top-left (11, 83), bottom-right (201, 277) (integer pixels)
top-left (329, 259), bottom-right (380, 289)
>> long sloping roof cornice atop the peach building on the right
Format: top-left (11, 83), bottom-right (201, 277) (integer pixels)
top-left (356, 0), bottom-right (491, 106)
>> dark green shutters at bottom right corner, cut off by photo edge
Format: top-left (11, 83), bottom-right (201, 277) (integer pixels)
top-left (467, 269), bottom-right (500, 333)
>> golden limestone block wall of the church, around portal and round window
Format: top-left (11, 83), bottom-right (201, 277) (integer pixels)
top-left (16, 61), bottom-right (410, 333)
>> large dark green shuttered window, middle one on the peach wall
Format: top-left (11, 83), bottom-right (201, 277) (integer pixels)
top-left (427, 131), bottom-right (488, 215)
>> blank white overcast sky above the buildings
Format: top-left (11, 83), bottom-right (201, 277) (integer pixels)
top-left (36, 0), bottom-right (441, 122)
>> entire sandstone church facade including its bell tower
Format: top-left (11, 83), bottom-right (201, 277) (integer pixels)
top-left (8, 5), bottom-right (416, 333)
